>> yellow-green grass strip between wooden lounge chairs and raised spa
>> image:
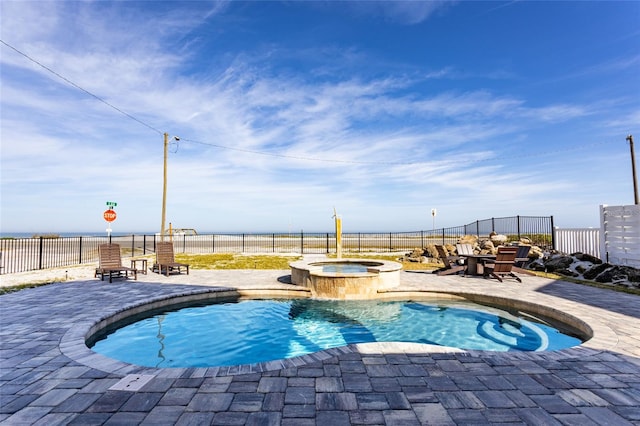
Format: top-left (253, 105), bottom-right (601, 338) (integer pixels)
top-left (176, 253), bottom-right (302, 269)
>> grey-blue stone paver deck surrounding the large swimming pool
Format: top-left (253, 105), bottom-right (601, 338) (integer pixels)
top-left (0, 262), bottom-right (640, 426)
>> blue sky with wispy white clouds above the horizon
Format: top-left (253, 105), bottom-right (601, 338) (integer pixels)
top-left (0, 0), bottom-right (640, 234)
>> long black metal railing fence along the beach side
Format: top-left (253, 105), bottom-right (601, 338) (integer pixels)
top-left (0, 216), bottom-right (554, 274)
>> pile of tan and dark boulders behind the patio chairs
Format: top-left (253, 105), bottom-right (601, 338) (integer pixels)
top-left (399, 233), bottom-right (640, 289)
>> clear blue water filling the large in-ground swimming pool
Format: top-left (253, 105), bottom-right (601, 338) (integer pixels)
top-left (89, 299), bottom-right (581, 367)
